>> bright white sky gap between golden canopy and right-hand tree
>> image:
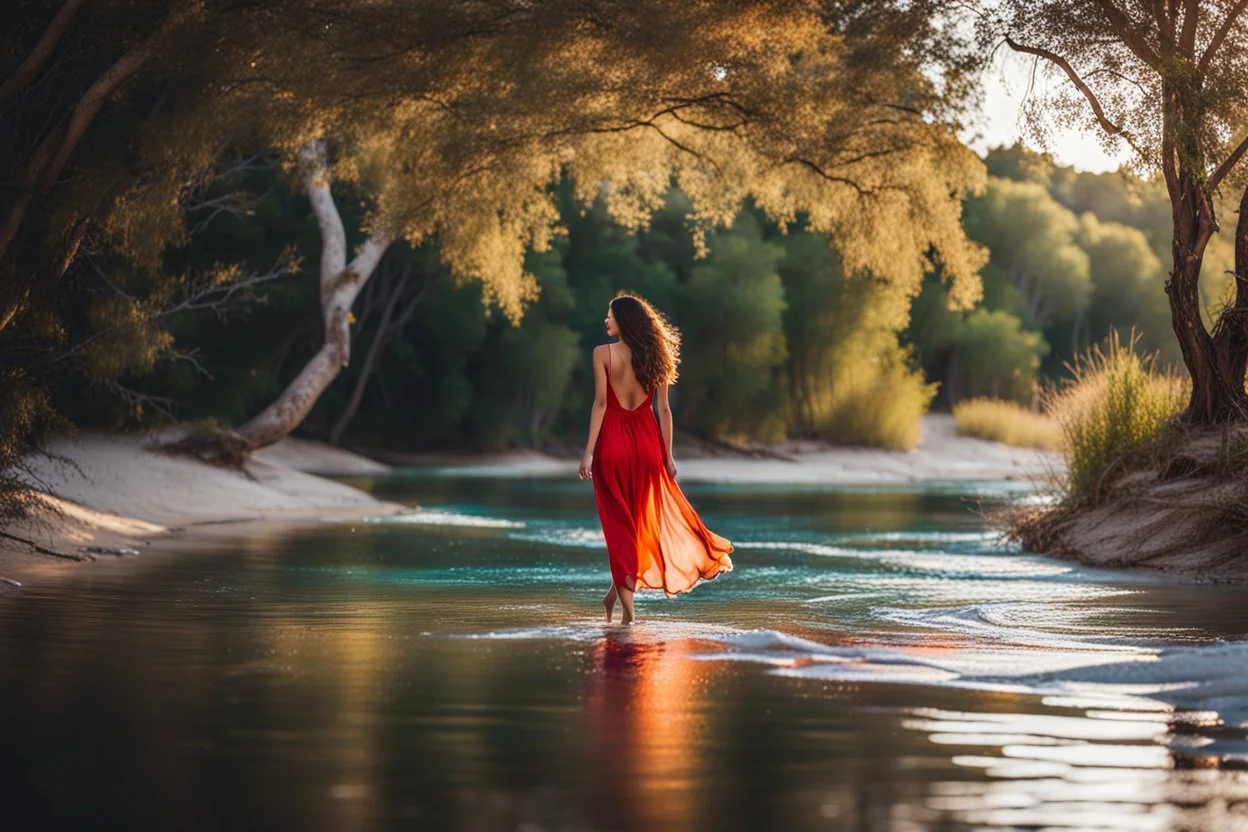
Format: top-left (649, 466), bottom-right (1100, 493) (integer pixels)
top-left (962, 47), bottom-right (1129, 172)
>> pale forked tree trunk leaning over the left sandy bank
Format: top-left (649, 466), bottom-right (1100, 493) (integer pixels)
top-left (237, 143), bottom-right (389, 450)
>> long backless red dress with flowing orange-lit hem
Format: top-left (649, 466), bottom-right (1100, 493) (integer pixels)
top-left (590, 344), bottom-right (733, 595)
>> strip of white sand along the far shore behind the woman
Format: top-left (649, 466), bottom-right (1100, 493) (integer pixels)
top-left (412, 414), bottom-right (1062, 485)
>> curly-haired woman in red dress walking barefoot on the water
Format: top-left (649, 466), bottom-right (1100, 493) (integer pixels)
top-left (579, 294), bottom-right (733, 624)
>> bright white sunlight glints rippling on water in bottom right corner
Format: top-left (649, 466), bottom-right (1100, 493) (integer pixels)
top-left (901, 709), bottom-right (1248, 831)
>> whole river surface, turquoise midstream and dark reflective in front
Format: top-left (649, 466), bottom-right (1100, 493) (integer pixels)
top-left (0, 473), bottom-right (1248, 832)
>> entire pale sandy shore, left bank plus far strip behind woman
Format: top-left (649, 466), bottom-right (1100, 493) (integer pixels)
top-left (0, 415), bottom-right (1060, 594)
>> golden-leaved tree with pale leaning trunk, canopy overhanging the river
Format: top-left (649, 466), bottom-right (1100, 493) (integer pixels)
top-left (0, 0), bottom-right (981, 461)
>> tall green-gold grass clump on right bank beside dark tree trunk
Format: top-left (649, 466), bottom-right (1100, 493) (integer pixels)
top-left (1043, 334), bottom-right (1188, 500)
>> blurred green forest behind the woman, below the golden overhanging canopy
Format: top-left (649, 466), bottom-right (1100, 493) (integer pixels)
top-left (57, 146), bottom-right (1218, 450)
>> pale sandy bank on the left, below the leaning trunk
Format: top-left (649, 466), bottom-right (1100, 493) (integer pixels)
top-left (0, 433), bottom-right (406, 591)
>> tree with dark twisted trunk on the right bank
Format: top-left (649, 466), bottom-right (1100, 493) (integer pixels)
top-left (981, 0), bottom-right (1248, 424)
